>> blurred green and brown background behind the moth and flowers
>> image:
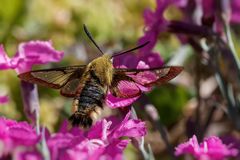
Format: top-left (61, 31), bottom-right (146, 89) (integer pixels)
top-left (0, 0), bottom-right (240, 160)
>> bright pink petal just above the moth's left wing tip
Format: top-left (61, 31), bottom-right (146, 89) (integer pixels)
top-left (11, 41), bottom-right (63, 73)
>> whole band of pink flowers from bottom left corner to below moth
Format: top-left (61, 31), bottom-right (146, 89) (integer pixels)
top-left (0, 112), bottom-right (146, 160)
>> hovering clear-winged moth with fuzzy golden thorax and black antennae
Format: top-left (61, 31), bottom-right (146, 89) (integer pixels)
top-left (18, 25), bottom-right (183, 128)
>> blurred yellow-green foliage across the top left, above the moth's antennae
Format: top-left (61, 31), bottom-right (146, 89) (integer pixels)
top-left (0, 0), bottom-right (154, 49)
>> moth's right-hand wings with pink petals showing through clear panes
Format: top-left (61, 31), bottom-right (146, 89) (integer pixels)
top-left (110, 66), bottom-right (183, 98)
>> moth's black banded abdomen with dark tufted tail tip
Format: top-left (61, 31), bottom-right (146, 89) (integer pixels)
top-left (69, 73), bottom-right (106, 127)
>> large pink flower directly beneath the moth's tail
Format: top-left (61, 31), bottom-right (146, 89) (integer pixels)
top-left (47, 112), bottom-right (146, 160)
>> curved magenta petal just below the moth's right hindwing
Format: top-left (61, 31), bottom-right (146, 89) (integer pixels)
top-left (106, 93), bottom-right (139, 108)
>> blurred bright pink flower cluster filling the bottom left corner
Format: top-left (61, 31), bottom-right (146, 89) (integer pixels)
top-left (0, 117), bottom-right (41, 160)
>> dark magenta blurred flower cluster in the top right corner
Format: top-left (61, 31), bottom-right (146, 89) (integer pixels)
top-left (139, 0), bottom-right (240, 43)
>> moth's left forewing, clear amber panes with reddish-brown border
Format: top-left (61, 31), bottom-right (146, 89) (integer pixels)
top-left (18, 65), bottom-right (86, 89)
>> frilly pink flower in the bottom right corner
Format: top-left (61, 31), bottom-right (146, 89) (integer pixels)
top-left (175, 135), bottom-right (238, 160)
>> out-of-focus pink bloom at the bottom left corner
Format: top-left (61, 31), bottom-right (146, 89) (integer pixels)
top-left (0, 117), bottom-right (39, 157)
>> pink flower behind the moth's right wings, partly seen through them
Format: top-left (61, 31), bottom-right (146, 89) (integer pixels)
top-left (106, 58), bottom-right (158, 108)
